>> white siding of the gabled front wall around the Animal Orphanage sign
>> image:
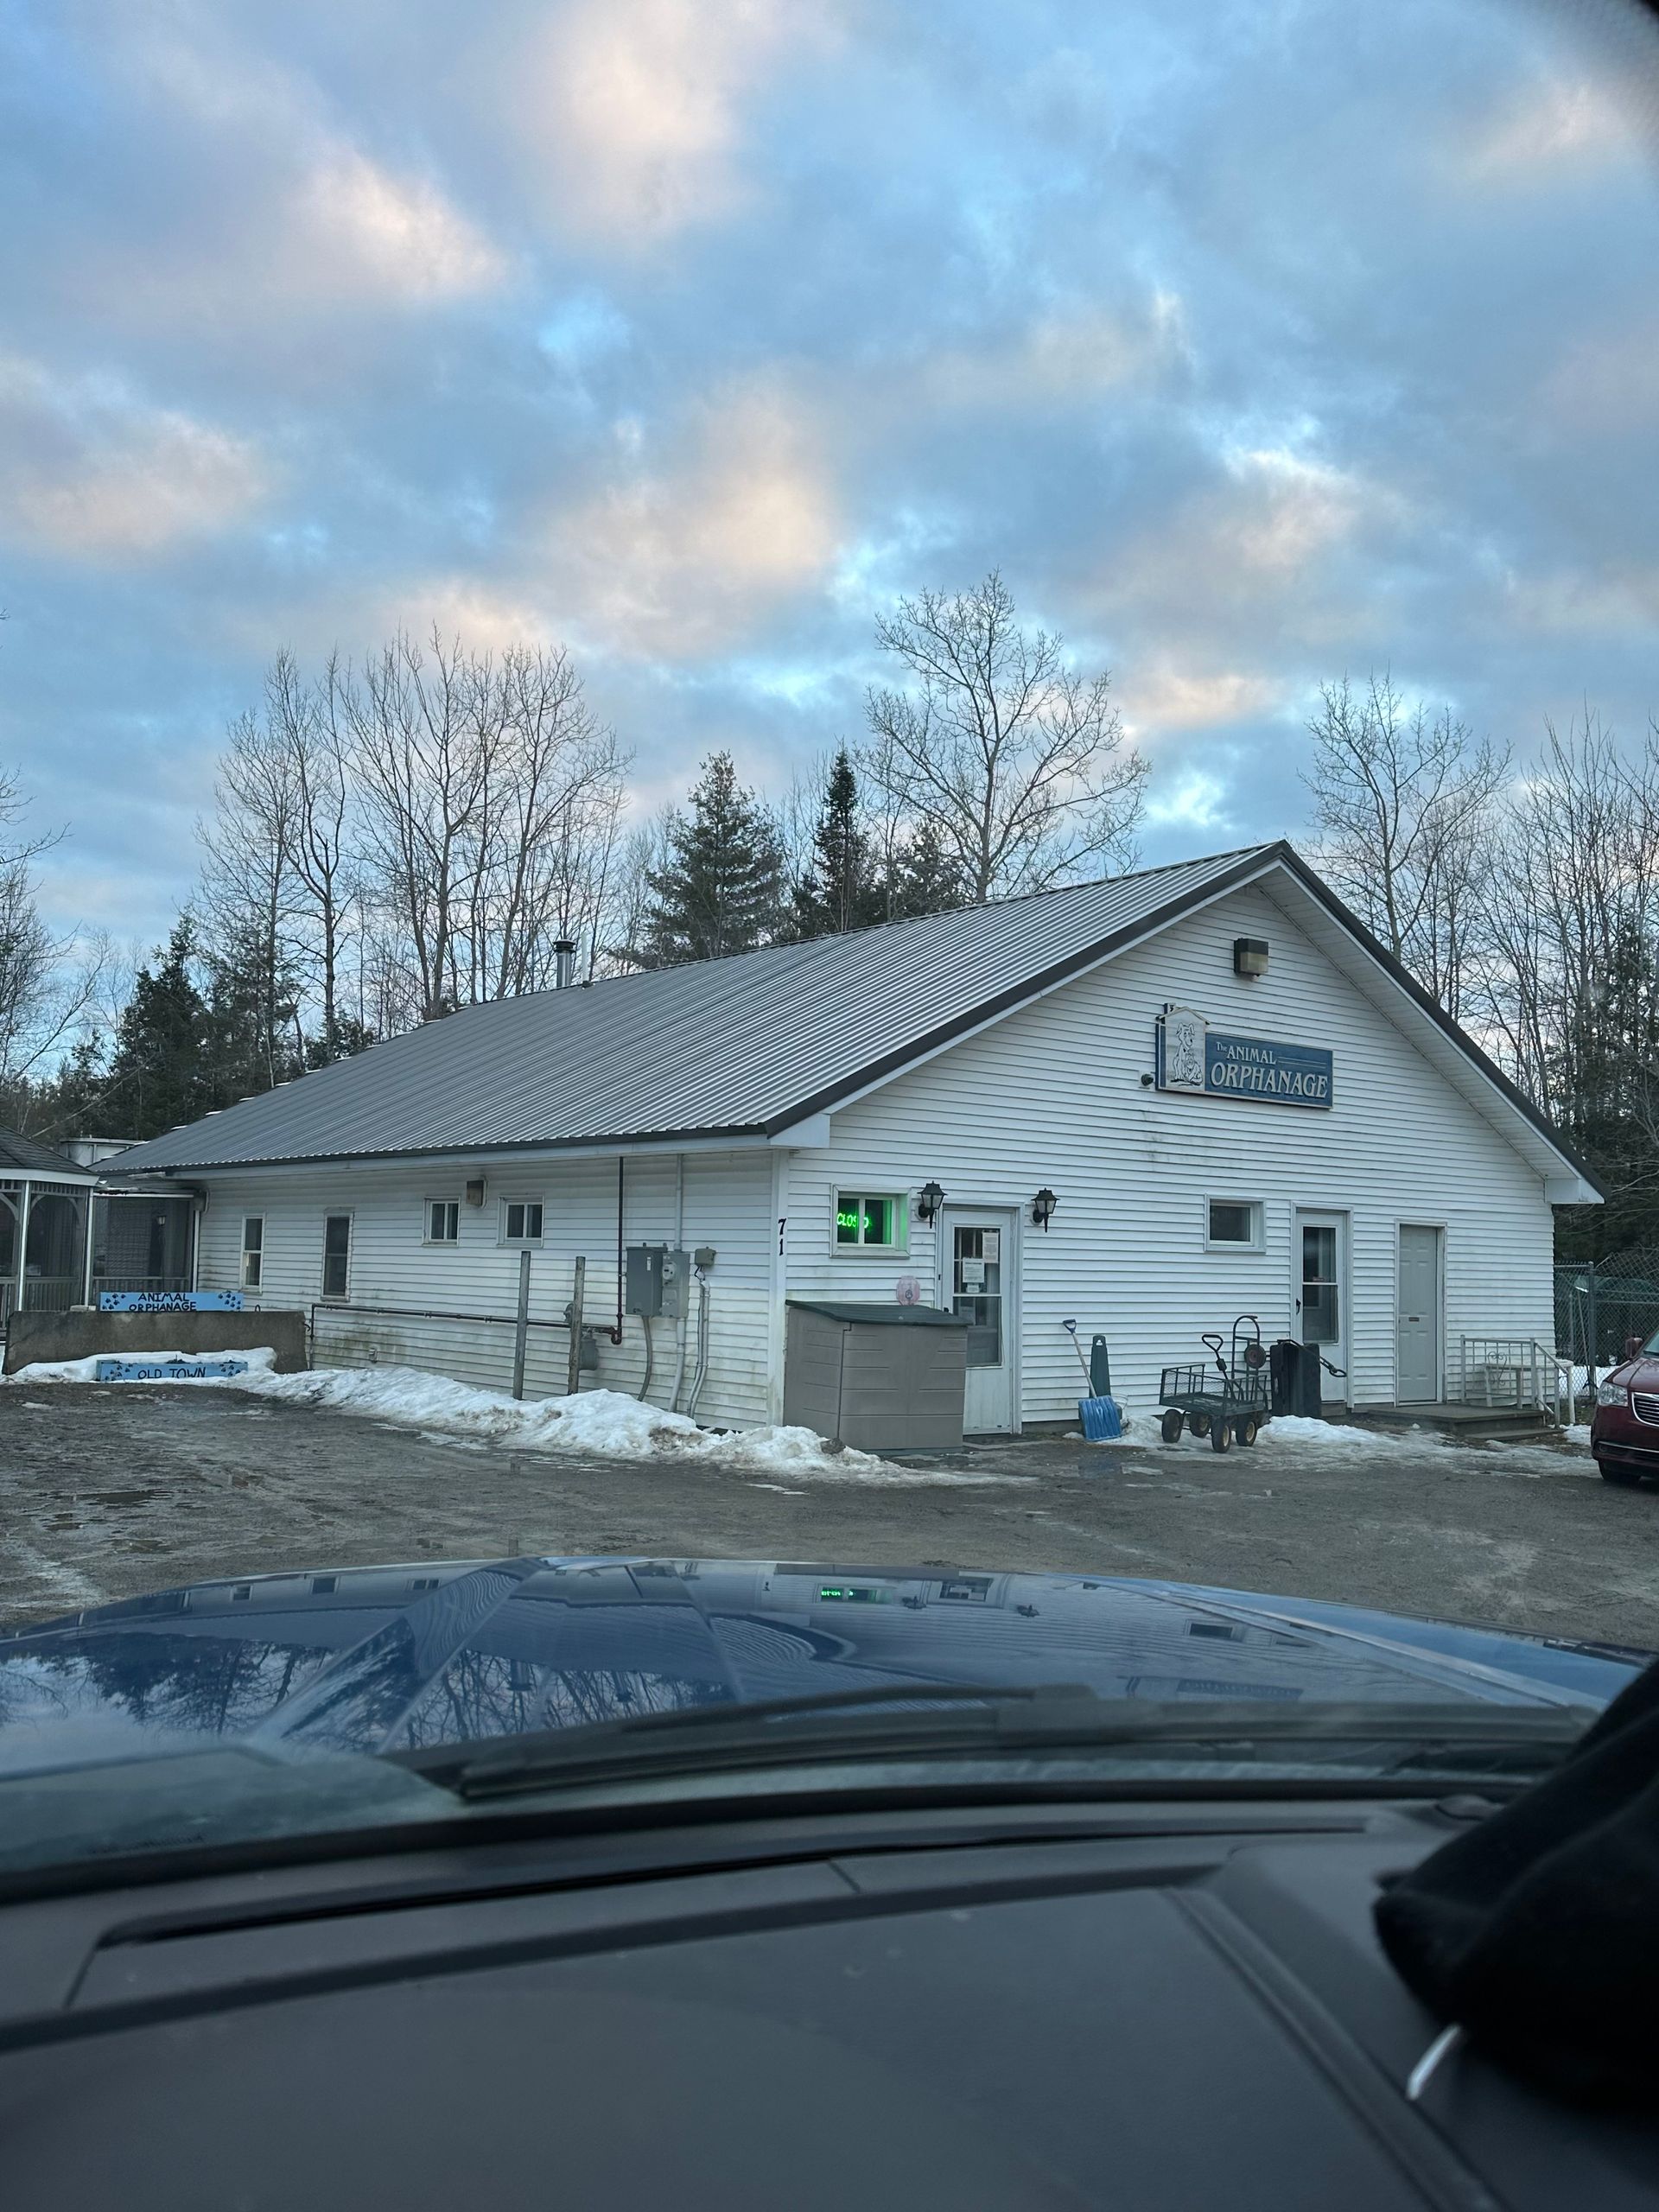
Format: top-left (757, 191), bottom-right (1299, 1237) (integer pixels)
top-left (787, 885), bottom-right (1553, 1422)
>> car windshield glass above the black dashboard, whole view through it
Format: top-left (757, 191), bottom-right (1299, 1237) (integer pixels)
top-left (0, 0), bottom-right (1659, 1869)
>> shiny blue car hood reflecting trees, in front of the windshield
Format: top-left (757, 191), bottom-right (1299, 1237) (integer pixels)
top-left (0, 1557), bottom-right (1646, 1772)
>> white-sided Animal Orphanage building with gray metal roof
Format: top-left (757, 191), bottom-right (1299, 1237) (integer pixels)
top-left (122, 845), bottom-right (1599, 1433)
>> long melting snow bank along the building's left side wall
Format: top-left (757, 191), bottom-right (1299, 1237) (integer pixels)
top-left (7, 1350), bottom-right (1020, 1486)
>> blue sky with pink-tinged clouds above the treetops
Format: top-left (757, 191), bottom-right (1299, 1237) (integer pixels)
top-left (0, 0), bottom-right (1659, 936)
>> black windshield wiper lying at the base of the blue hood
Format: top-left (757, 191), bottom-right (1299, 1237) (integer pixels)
top-left (385, 1681), bottom-right (1591, 1801)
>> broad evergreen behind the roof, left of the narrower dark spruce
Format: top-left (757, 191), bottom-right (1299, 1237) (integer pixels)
top-left (639, 752), bottom-right (783, 967)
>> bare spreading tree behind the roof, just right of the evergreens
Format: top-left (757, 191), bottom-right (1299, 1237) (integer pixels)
top-left (861, 570), bottom-right (1146, 900)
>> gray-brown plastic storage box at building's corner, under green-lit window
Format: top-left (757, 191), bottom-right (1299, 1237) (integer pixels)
top-left (783, 1299), bottom-right (967, 1451)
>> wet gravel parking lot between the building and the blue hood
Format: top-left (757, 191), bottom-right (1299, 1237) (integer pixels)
top-left (0, 1385), bottom-right (1659, 1648)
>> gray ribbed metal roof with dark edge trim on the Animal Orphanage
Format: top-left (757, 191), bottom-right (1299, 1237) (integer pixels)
top-left (107, 845), bottom-right (1601, 1173)
